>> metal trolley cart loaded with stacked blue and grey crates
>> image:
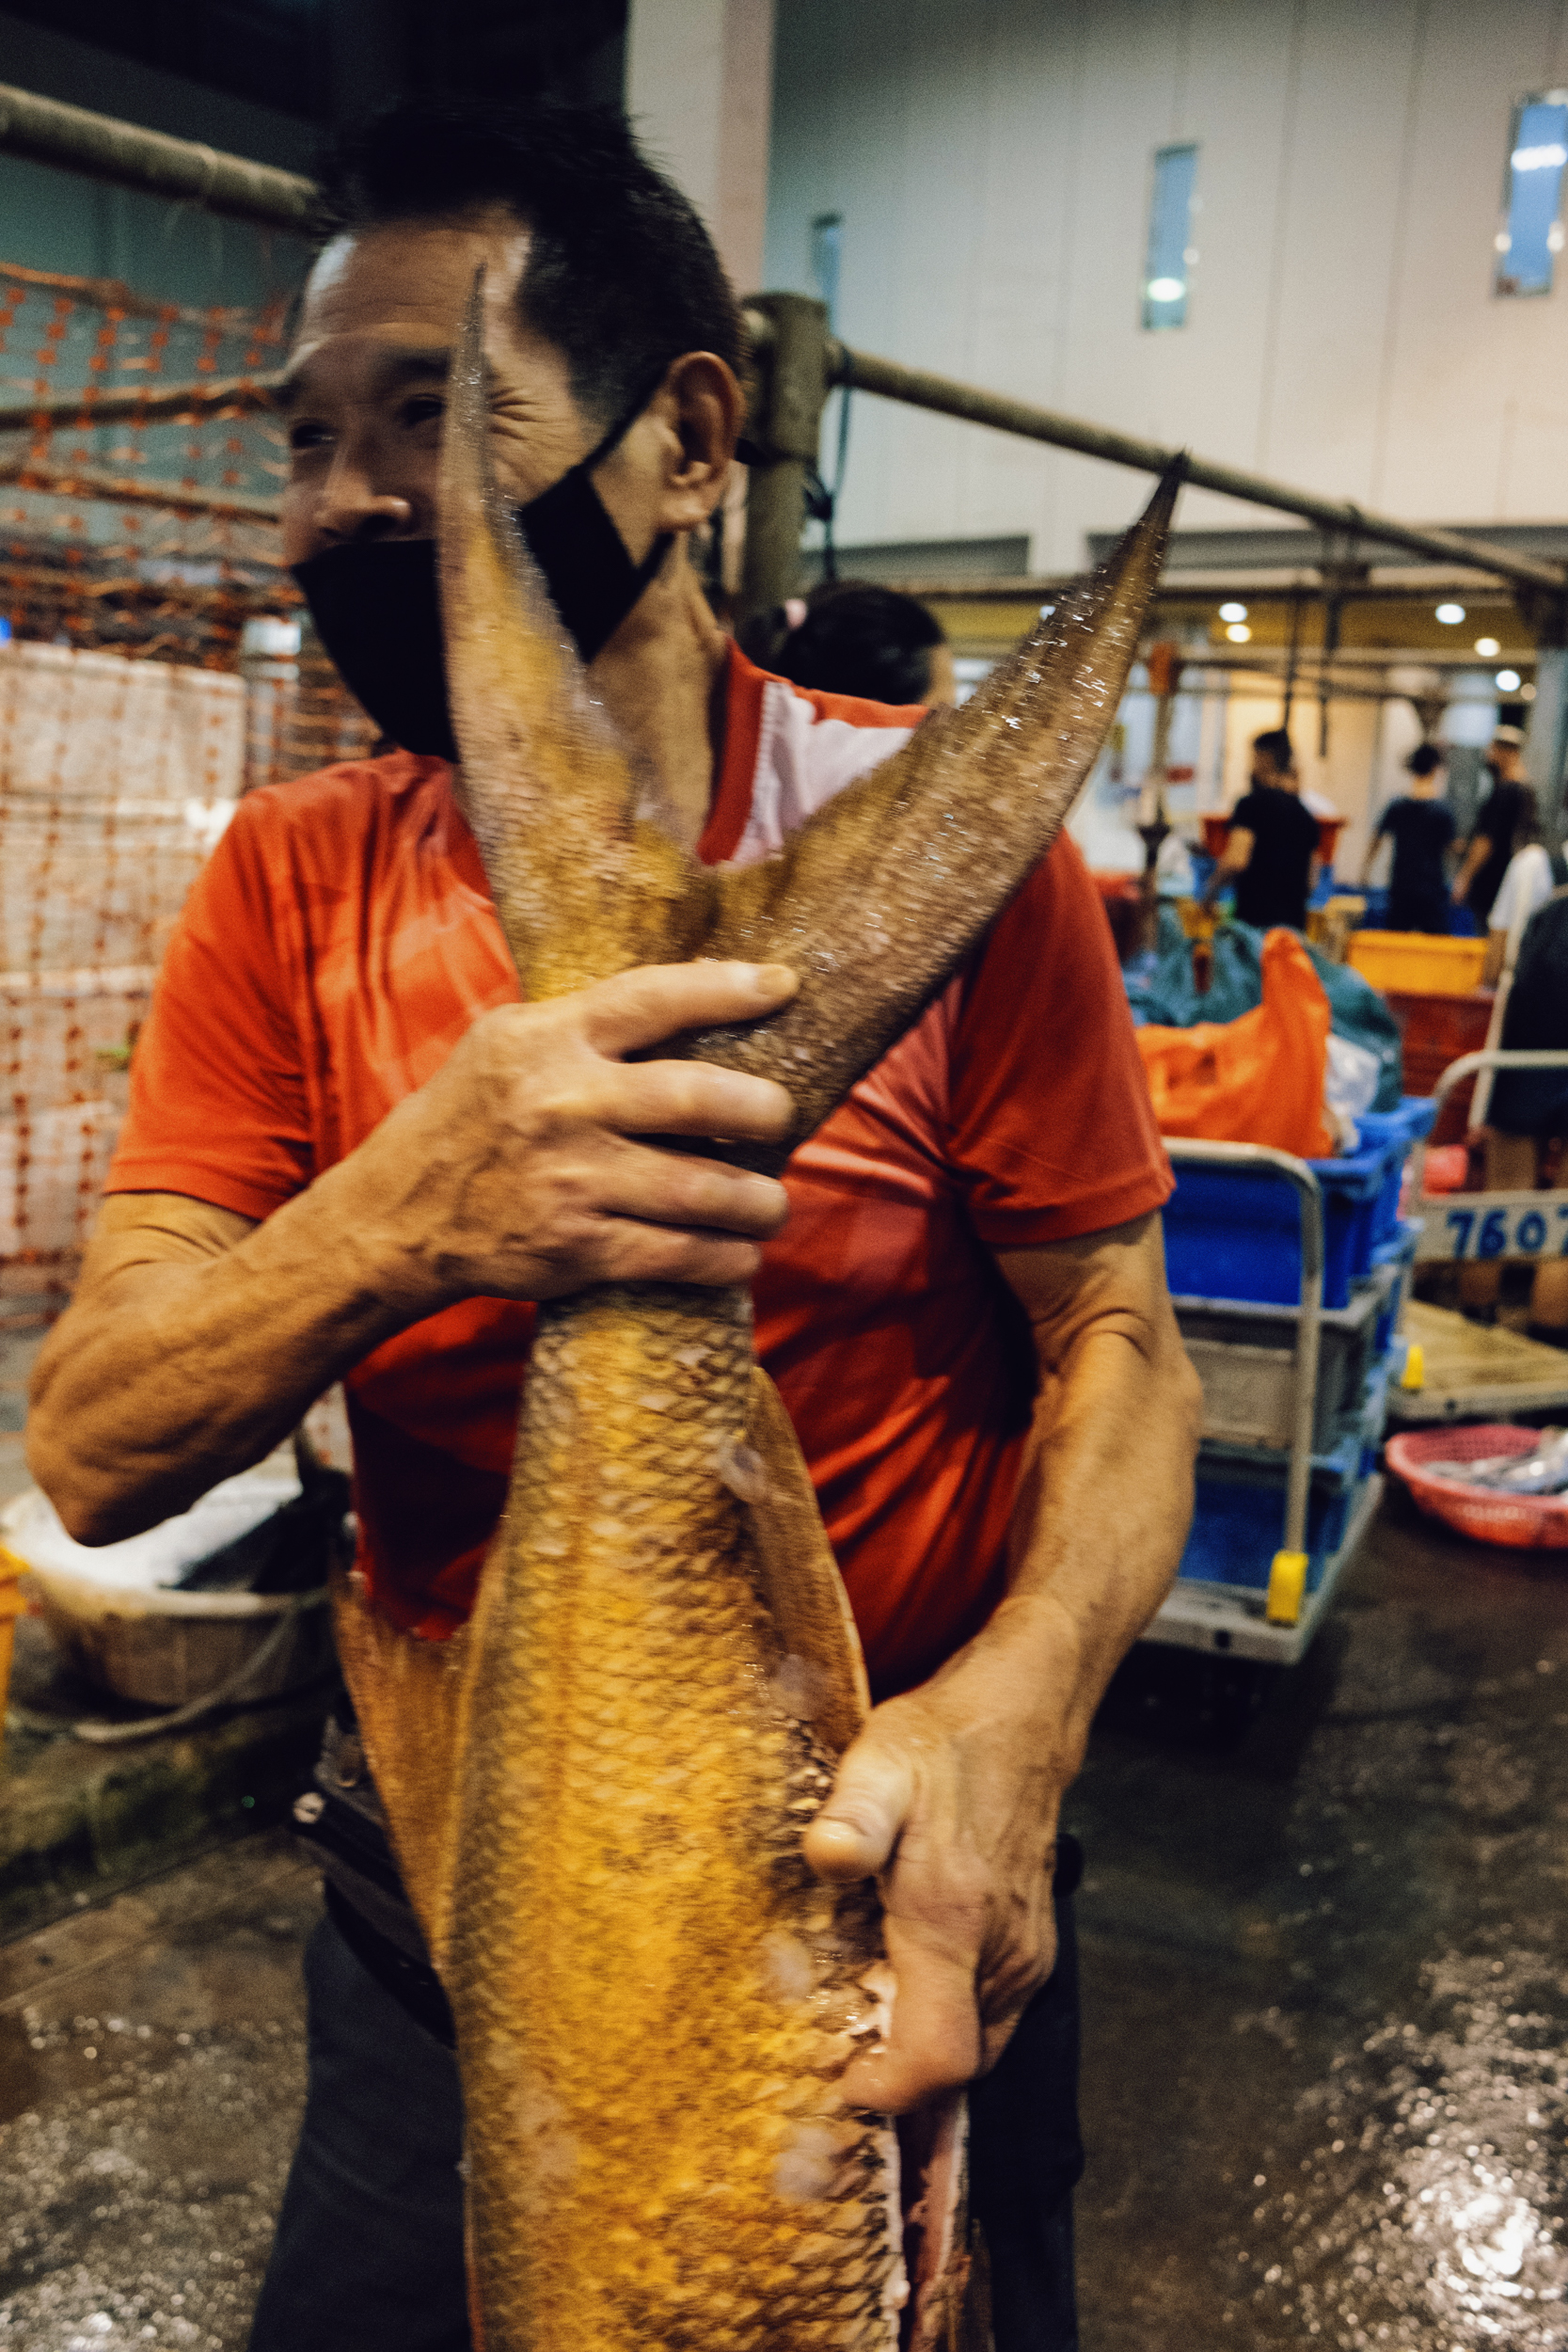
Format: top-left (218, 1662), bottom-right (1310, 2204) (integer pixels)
top-left (1145, 1138), bottom-right (1394, 1665)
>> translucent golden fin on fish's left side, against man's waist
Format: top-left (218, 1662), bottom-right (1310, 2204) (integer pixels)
top-left (331, 1576), bottom-right (472, 1974)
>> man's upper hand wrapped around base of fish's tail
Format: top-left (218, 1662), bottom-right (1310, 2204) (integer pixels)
top-left (345, 964), bottom-right (797, 1320)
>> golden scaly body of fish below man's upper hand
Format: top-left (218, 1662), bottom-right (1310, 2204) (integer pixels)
top-left (449, 1289), bottom-right (898, 2352)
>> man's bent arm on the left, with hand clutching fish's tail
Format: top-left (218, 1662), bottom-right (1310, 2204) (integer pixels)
top-left (28, 964), bottom-right (795, 1543)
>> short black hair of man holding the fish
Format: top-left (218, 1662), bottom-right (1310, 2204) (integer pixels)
top-left (322, 99), bottom-right (740, 426)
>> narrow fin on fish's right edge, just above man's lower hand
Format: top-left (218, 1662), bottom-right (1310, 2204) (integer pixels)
top-left (736, 1367), bottom-right (872, 1755)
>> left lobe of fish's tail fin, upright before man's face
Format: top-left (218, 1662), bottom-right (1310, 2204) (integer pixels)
top-left (439, 271), bottom-right (707, 997)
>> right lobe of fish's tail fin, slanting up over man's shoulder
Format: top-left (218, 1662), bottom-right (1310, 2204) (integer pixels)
top-left (677, 466), bottom-right (1180, 1167)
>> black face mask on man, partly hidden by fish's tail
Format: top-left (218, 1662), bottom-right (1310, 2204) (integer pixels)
top-left (293, 390), bottom-right (670, 760)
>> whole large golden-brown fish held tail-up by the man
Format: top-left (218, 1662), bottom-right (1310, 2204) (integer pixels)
top-left (341, 292), bottom-right (1176, 2352)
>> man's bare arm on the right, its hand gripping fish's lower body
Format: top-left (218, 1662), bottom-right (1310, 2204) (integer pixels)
top-left (806, 1216), bottom-right (1201, 2112)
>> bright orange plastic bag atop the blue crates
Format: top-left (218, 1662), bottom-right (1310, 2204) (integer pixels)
top-left (1138, 931), bottom-right (1336, 1160)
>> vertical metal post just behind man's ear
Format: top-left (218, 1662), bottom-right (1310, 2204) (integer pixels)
top-left (738, 294), bottom-right (828, 621)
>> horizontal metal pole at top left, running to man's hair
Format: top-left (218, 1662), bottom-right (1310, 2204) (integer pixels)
top-left (0, 83), bottom-right (320, 238)
